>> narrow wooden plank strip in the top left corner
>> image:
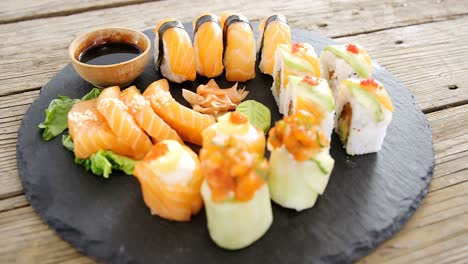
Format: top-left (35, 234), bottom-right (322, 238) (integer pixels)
top-left (0, 0), bottom-right (154, 24)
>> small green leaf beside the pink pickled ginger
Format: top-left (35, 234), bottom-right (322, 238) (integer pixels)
top-left (236, 100), bottom-right (271, 134)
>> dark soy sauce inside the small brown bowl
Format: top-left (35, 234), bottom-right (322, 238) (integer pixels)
top-left (78, 42), bottom-right (142, 65)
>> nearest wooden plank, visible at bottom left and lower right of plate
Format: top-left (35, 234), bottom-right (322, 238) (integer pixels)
top-left (0, 104), bottom-right (468, 263)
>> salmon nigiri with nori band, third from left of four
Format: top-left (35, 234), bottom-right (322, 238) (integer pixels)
top-left (221, 13), bottom-right (256, 82)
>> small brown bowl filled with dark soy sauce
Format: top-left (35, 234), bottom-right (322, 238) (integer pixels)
top-left (68, 28), bottom-right (151, 88)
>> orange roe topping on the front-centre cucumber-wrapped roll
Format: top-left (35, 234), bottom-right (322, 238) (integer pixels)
top-left (200, 146), bottom-right (268, 202)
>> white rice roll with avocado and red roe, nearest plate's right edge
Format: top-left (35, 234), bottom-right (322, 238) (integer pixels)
top-left (335, 79), bottom-right (393, 155)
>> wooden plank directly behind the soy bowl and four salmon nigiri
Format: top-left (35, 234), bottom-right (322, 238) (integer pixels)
top-left (0, 0), bottom-right (468, 95)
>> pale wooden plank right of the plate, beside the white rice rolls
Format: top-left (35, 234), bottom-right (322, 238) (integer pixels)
top-left (337, 17), bottom-right (468, 112)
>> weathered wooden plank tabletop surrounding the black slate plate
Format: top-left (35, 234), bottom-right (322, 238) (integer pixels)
top-left (0, 0), bottom-right (468, 263)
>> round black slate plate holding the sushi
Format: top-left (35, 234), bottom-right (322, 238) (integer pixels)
top-left (17, 24), bottom-right (434, 263)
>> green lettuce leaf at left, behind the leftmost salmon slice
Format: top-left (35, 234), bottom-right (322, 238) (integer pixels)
top-left (38, 88), bottom-right (101, 141)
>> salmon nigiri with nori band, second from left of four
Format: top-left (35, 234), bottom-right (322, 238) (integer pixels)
top-left (193, 13), bottom-right (224, 78)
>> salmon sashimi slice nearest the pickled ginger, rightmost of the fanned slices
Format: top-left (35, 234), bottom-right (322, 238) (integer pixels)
top-left (143, 79), bottom-right (215, 146)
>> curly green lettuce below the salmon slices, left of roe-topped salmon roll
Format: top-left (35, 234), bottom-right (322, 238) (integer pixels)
top-left (62, 135), bottom-right (136, 179)
